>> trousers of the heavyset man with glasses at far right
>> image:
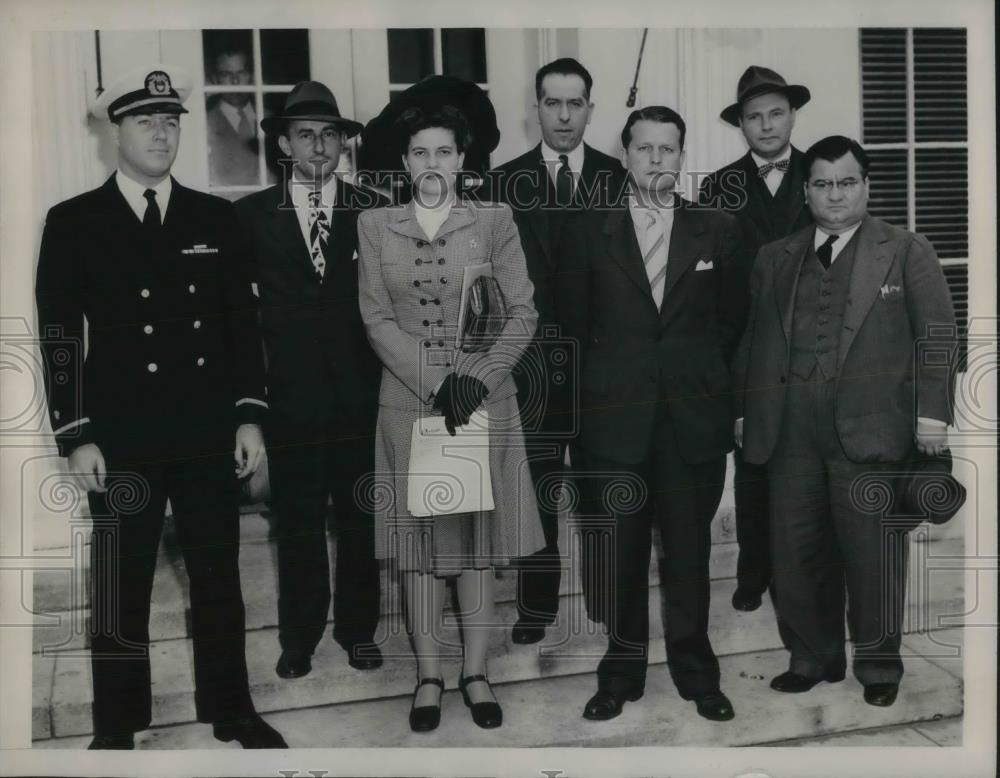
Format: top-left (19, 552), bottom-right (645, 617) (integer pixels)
top-left (768, 372), bottom-right (909, 684)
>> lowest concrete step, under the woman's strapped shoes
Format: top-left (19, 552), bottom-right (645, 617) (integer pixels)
top-left (34, 628), bottom-right (963, 748)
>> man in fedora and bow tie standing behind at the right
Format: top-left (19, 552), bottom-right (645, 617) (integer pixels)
top-left (700, 65), bottom-right (812, 611)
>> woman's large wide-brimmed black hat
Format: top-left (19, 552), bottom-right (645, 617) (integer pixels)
top-left (360, 76), bottom-right (500, 174)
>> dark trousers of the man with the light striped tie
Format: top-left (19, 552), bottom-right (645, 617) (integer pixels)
top-left (585, 406), bottom-right (726, 699)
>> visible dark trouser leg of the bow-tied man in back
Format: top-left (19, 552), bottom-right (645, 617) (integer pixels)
top-left (733, 448), bottom-right (771, 594)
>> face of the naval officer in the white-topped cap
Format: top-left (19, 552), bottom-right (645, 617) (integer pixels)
top-left (111, 113), bottom-right (181, 186)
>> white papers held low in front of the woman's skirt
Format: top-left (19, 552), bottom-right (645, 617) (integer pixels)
top-left (406, 410), bottom-right (494, 516)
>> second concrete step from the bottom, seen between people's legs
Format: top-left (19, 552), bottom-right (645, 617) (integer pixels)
top-left (33, 571), bottom-right (963, 738)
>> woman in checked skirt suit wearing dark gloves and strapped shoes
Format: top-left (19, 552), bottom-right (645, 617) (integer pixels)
top-left (358, 106), bottom-right (544, 731)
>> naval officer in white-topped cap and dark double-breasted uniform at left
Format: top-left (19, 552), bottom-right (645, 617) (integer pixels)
top-left (36, 65), bottom-right (287, 749)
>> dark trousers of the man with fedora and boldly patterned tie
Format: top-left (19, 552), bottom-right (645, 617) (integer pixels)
top-left (268, 412), bottom-right (379, 655)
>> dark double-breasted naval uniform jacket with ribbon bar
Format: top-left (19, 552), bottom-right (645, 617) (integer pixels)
top-left (36, 175), bottom-right (267, 467)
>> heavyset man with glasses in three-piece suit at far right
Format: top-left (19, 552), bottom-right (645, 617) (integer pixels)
top-left (734, 136), bottom-right (955, 706)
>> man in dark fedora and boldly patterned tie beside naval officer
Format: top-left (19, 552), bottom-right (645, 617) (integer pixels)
top-left (236, 81), bottom-right (382, 678)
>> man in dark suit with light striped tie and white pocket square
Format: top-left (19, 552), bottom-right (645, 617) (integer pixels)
top-left (556, 106), bottom-right (743, 721)
